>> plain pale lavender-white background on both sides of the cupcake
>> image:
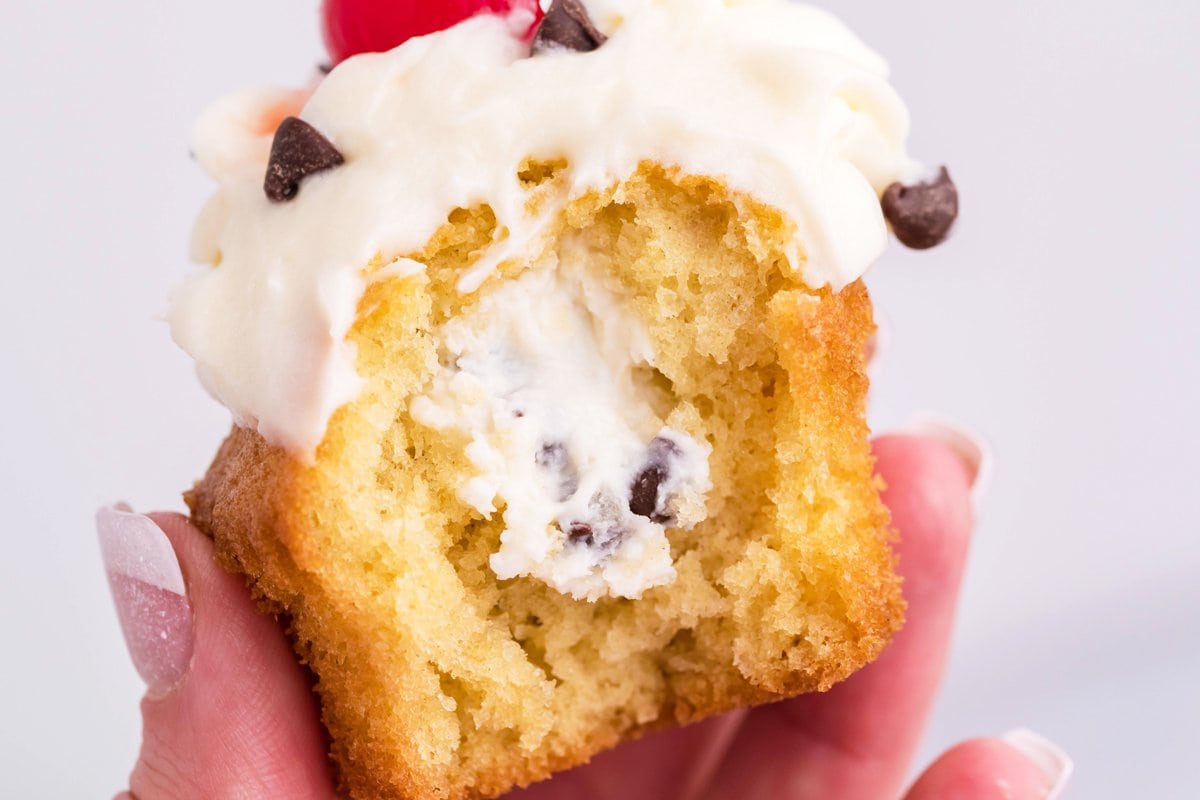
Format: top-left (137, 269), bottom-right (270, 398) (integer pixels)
top-left (0, 0), bottom-right (1200, 800)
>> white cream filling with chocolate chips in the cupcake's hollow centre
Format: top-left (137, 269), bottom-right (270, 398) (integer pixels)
top-left (409, 251), bottom-right (712, 600)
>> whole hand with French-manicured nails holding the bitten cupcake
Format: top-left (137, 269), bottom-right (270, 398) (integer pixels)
top-left (97, 431), bottom-right (1070, 800)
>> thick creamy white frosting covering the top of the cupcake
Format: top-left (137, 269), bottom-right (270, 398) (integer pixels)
top-left (169, 0), bottom-right (912, 457)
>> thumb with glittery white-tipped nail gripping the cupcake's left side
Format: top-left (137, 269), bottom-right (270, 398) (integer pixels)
top-left (96, 509), bottom-right (332, 800)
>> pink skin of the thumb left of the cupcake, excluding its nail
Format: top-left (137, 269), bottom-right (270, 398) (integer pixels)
top-left (131, 512), bottom-right (331, 799)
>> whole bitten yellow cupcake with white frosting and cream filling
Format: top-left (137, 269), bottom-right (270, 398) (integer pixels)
top-left (172, 0), bottom-right (955, 800)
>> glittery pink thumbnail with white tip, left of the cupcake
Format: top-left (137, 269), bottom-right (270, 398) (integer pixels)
top-left (96, 504), bottom-right (192, 698)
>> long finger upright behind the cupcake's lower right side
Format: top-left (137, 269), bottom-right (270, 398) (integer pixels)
top-left (707, 437), bottom-right (982, 800)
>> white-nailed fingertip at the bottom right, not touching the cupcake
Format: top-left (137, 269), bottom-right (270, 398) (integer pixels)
top-left (905, 730), bottom-right (1072, 800)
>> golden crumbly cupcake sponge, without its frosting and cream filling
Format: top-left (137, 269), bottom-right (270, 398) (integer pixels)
top-left (187, 163), bottom-right (904, 800)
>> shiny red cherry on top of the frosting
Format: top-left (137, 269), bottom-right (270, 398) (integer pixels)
top-left (324, 0), bottom-right (542, 64)
